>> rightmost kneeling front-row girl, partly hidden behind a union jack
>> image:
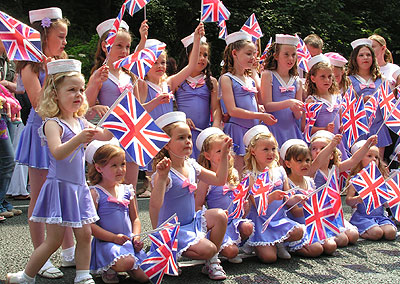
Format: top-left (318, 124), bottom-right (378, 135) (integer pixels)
top-left (346, 140), bottom-right (397, 241)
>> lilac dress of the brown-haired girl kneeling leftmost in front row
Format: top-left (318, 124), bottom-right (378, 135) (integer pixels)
top-left (90, 184), bottom-right (146, 273)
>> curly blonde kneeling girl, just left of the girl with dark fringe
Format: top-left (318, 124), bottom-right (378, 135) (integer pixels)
top-left (243, 125), bottom-right (307, 263)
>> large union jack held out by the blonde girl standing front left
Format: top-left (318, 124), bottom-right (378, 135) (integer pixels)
top-left (102, 91), bottom-right (170, 166)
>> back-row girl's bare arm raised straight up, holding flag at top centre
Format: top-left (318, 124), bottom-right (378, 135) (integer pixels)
top-left (167, 22), bottom-right (205, 91)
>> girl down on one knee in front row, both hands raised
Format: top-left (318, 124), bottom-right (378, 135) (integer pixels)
top-left (149, 112), bottom-right (232, 280)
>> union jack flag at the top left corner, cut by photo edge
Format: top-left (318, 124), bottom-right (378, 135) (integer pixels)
top-left (0, 11), bottom-right (44, 62)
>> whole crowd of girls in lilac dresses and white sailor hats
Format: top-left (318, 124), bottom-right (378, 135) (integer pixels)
top-left (0, 4), bottom-right (400, 284)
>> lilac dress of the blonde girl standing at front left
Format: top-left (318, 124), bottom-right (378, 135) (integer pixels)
top-left (30, 118), bottom-right (99, 228)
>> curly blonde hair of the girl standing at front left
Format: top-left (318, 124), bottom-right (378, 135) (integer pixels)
top-left (36, 72), bottom-right (89, 118)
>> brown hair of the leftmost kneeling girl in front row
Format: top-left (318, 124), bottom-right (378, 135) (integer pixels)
top-left (88, 144), bottom-right (125, 185)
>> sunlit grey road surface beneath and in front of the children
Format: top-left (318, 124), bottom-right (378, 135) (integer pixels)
top-left (0, 196), bottom-right (400, 284)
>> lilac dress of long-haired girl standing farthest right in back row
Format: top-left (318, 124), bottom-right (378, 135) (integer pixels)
top-left (349, 75), bottom-right (392, 147)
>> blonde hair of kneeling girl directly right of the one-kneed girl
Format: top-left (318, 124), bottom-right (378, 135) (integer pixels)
top-left (197, 134), bottom-right (239, 186)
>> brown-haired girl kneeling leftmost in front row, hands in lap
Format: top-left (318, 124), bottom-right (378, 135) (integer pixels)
top-left (86, 141), bottom-right (148, 283)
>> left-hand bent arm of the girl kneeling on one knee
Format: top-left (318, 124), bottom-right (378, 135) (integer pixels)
top-left (149, 157), bottom-right (171, 228)
